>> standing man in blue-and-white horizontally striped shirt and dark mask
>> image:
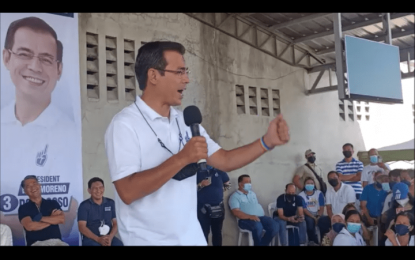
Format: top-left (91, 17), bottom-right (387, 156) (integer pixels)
top-left (336, 143), bottom-right (363, 210)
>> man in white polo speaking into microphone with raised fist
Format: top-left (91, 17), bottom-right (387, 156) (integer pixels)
top-left (105, 42), bottom-right (289, 246)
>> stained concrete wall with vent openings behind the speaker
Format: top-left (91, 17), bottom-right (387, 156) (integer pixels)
top-left (79, 13), bottom-right (365, 245)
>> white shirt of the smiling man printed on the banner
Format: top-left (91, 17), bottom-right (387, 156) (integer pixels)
top-left (0, 102), bottom-right (82, 215)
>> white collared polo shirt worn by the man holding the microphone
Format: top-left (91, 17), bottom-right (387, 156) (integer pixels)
top-left (105, 96), bottom-right (220, 246)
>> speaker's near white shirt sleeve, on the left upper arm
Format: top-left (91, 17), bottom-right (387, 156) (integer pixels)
top-left (105, 118), bottom-right (141, 182)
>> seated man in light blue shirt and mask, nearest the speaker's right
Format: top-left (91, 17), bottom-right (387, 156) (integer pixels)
top-left (229, 174), bottom-right (279, 246)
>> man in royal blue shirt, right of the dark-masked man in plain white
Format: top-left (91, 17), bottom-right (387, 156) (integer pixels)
top-left (360, 171), bottom-right (389, 226)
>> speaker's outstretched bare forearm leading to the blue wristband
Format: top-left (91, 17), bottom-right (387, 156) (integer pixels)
top-left (207, 139), bottom-right (265, 172)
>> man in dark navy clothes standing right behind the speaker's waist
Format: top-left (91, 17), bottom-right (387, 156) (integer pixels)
top-left (197, 165), bottom-right (230, 246)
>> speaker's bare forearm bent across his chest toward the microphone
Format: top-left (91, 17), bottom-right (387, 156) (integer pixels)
top-left (114, 155), bottom-right (190, 205)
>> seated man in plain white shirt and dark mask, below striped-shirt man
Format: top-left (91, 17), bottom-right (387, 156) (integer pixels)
top-left (319, 171), bottom-right (356, 240)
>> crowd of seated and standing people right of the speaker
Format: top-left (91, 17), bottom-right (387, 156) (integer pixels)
top-left (229, 146), bottom-right (414, 246)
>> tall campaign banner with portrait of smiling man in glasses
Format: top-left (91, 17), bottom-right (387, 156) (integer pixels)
top-left (0, 13), bottom-right (83, 245)
